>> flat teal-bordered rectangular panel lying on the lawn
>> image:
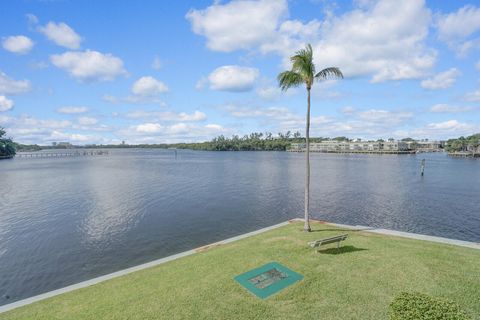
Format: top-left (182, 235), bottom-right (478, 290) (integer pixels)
top-left (235, 262), bottom-right (303, 299)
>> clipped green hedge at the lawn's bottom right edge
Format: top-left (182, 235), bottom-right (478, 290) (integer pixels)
top-left (390, 292), bottom-right (472, 320)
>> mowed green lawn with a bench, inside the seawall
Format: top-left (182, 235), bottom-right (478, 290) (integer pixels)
top-left (0, 223), bottom-right (480, 320)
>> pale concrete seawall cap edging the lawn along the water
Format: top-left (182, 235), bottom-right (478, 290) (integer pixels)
top-left (0, 218), bottom-right (480, 313)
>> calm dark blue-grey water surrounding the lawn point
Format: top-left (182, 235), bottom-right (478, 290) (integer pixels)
top-left (0, 150), bottom-right (480, 305)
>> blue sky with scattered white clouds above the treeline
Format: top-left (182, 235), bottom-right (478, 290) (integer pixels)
top-left (0, 0), bottom-right (480, 144)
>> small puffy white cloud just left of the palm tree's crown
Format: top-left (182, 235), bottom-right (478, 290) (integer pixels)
top-left (208, 66), bottom-right (259, 92)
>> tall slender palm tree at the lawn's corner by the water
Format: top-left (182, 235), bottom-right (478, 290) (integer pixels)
top-left (277, 44), bottom-right (343, 231)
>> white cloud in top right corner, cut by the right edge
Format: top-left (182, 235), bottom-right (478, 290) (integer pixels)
top-left (436, 5), bottom-right (480, 42)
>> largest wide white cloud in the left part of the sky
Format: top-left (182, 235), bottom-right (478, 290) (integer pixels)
top-left (50, 50), bottom-right (127, 81)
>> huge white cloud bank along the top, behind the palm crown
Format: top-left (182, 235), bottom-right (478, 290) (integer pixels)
top-left (187, 0), bottom-right (436, 82)
